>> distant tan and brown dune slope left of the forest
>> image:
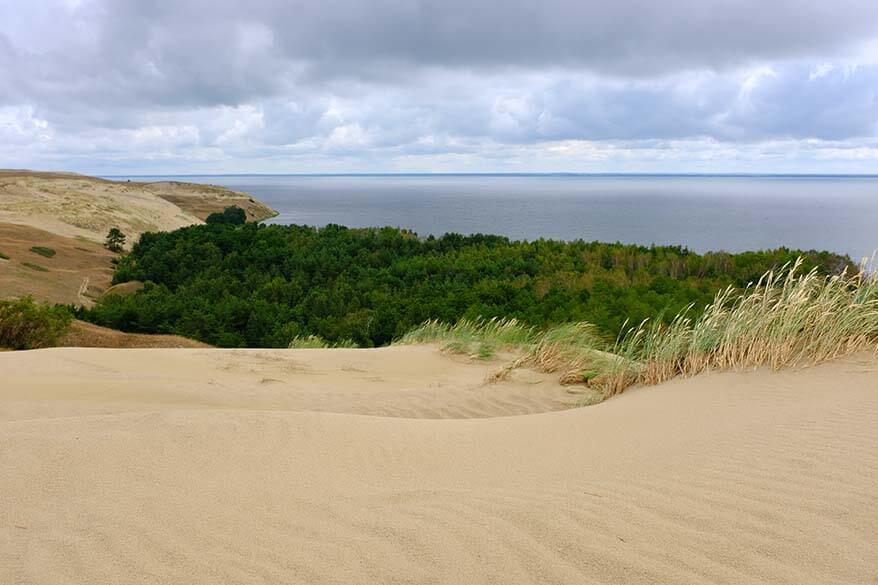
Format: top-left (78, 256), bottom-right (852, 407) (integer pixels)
top-left (0, 170), bottom-right (275, 306)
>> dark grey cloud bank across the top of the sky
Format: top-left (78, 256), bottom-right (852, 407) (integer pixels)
top-left (6, 0), bottom-right (878, 107)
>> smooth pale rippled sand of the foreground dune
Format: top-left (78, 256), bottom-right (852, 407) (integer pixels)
top-left (0, 346), bottom-right (878, 585)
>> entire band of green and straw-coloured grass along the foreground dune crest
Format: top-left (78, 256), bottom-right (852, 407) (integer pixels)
top-left (400, 260), bottom-right (878, 398)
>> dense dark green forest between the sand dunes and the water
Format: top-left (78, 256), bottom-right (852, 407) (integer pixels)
top-left (79, 218), bottom-right (850, 347)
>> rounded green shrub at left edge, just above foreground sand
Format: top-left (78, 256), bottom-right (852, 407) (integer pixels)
top-left (0, 297), bottom-right (73, 349)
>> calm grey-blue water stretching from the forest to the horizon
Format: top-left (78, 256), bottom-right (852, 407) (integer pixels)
top-left (113, 175), bottom-right (878, 260)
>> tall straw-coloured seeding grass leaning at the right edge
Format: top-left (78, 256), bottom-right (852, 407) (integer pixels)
top-left (593, 261), bottom-right (878, 396)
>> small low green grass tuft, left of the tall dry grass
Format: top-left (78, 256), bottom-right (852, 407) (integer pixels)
top-left (396, 318), bottom-right (536, 359)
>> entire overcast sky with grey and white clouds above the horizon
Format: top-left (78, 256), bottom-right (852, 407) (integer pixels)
top-left (0, 0), bottom-right (878, 174)
